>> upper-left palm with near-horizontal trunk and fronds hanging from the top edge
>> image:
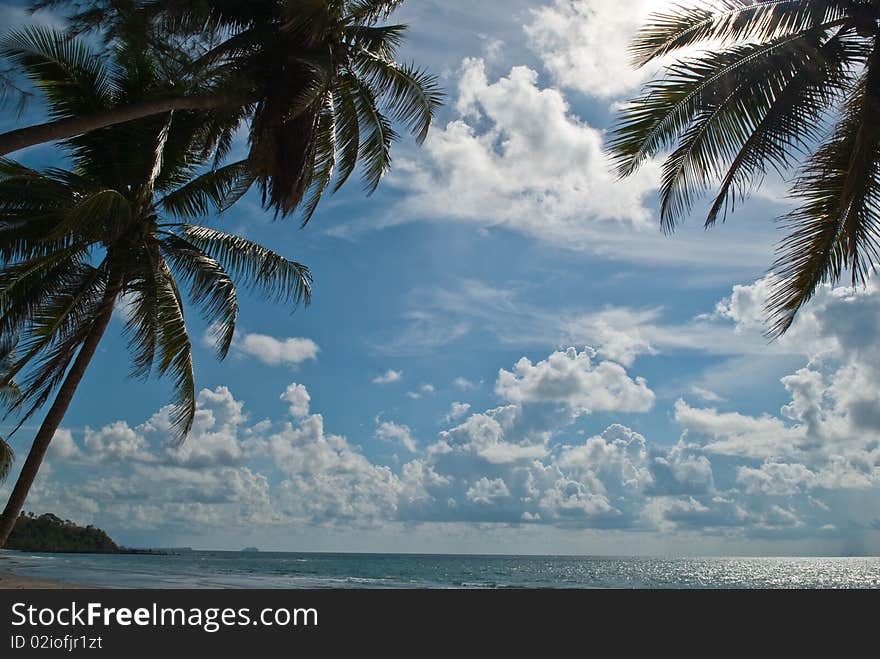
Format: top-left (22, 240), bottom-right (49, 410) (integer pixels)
top-left (0, 0), bottom-right (442, 223)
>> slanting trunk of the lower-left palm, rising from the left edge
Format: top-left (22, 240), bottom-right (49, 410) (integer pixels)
top-left (0, 277), bottom-right (121, 548)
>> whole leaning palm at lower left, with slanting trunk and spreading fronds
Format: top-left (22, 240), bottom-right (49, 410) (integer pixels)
top-left (0, 36), bottom-right (311, 546)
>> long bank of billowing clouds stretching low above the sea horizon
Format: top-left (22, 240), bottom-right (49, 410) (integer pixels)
top-left (17, 281), bottom-right (880, 552)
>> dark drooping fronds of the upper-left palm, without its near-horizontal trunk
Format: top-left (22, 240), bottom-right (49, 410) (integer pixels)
top-left (0, 0), bottom-right (443, 224)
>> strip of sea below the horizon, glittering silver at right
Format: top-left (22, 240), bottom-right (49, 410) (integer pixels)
top-left (0, 551), bottom-right (880, 589)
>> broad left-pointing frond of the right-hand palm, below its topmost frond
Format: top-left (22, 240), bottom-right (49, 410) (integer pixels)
top-left (608, 30), bottom-right (851, 230)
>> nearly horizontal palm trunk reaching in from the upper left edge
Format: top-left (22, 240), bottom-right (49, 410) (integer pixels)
top-left (0, 95), bottom-right (239, 156)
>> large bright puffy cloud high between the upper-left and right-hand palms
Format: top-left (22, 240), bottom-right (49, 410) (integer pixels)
top-left (368, 59), bottom-right (659, 248)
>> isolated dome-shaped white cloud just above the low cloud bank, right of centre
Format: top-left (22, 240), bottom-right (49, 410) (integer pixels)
top-left (495, 348), bottom-right (654, 414)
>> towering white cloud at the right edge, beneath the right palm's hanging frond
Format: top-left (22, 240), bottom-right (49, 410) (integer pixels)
top-left (675, 275), bottom-right (880, 502)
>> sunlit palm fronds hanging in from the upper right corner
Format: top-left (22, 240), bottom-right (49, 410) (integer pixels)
top-left (609, 0), bottom-right (880, 336)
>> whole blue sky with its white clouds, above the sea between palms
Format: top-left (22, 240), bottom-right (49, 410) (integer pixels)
top-left (0, 0), bottom-right (880, 554)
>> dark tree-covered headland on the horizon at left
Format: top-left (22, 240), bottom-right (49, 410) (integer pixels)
top-left (6, 513), bottom-right (166, 554)
